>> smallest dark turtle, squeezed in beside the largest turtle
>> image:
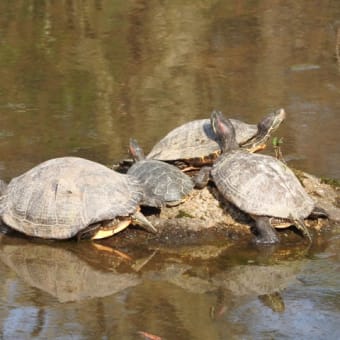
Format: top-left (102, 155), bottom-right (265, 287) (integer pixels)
top-left (127, 138), bottom-right (194, 208)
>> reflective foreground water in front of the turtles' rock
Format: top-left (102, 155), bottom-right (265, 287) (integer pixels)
top-left (0, 231), bottom-right (340, 339)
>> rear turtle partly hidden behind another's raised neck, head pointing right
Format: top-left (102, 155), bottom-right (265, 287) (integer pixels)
top-left (146, 108), bottom-right (285, 170)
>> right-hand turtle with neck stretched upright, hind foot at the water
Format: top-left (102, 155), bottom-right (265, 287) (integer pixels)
top-left (211, 111), bottom-right (315, 244)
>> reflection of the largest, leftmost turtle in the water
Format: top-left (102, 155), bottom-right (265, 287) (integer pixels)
top-left (0, 236), bottom-right (140, 302)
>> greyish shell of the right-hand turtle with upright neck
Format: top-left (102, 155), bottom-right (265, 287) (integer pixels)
top-left (211, 150), bottom-right (314, 221)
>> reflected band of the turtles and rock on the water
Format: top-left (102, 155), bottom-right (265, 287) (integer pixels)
top-left (0, 235), bottom-right (304, 311)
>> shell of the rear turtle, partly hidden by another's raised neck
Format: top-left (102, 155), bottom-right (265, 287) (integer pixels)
top-left (146, 119), bottom-right (258, 163)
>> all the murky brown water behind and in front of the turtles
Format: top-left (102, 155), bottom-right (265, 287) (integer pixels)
top-left (0, 0), bottom-right (340, 339)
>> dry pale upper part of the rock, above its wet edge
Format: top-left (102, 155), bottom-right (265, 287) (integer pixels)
top-left (144, 171), bottom-right (340, 233)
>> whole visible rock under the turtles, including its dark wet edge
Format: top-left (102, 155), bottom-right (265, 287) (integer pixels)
top-left (97, 171), bottom-right (340, 249)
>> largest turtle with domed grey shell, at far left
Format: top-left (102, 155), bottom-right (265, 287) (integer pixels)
top-left (0, 157), bottom-right (157, 239)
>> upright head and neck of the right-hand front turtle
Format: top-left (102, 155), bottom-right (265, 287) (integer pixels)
top-left (210, 111), bottom-right (239, 152)
